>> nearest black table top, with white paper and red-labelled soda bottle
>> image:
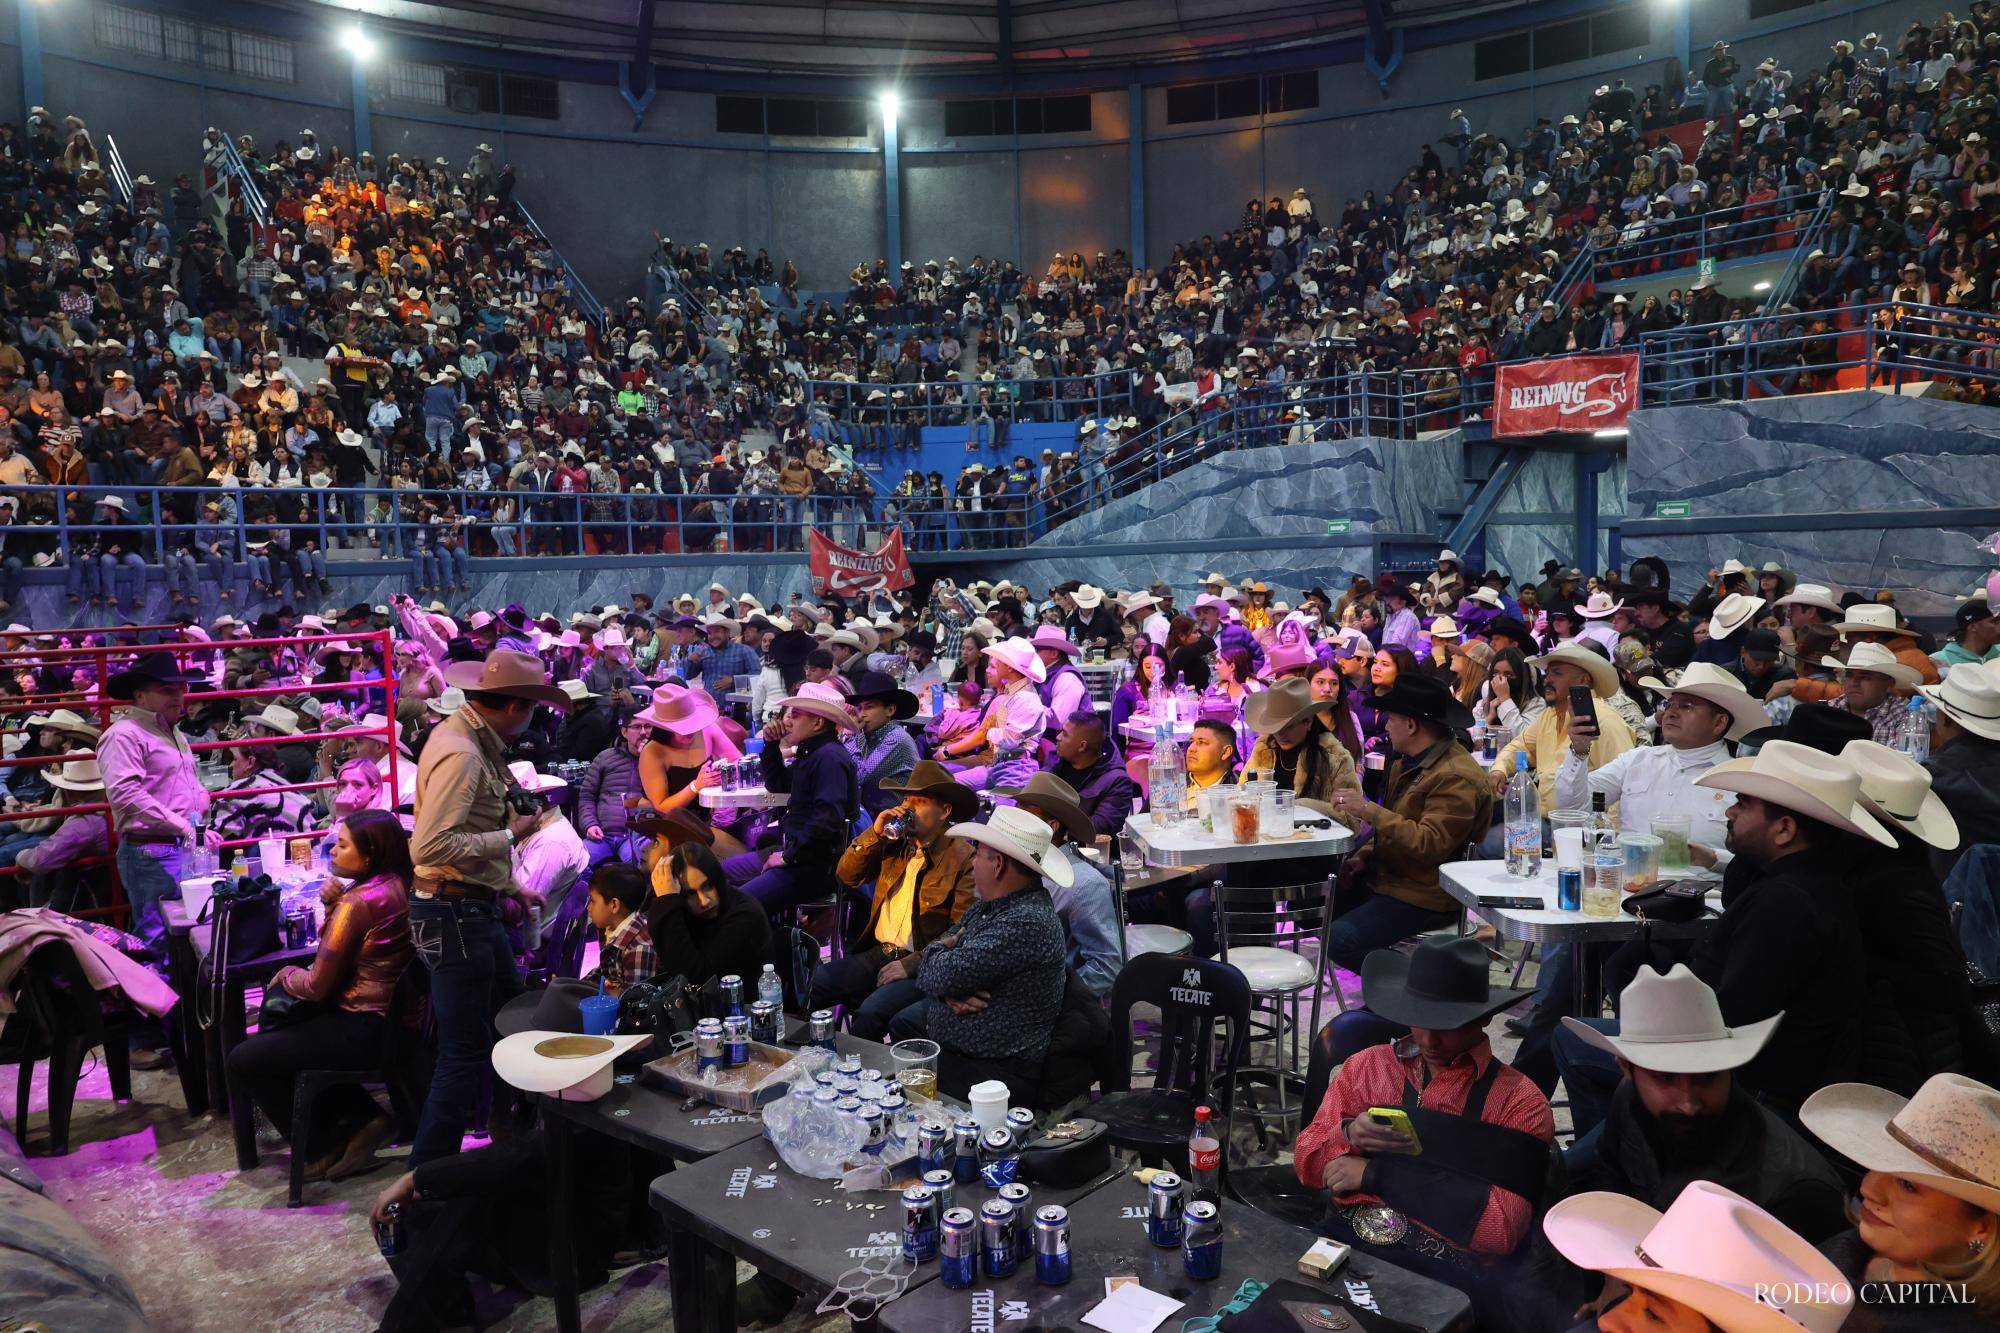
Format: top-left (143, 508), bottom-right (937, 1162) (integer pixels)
top-left (880, 1179), bottom-right (1472, 1333)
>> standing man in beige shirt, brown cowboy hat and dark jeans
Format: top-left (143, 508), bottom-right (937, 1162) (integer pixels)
top-left (410, 648), bottom-right (570, 1169)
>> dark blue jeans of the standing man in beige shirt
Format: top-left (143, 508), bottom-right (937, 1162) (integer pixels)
top-left (410, 897), bottom-right (520, 1169)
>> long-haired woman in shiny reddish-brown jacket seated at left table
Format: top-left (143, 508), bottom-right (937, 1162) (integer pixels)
top-left (230, 811), bottom-right (414, 1181)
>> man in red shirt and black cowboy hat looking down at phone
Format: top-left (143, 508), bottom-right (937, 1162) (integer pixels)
top-left (1292, 928), bottom-right (1556, 1293)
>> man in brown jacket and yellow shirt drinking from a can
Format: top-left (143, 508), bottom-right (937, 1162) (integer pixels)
top-left (810, 756), bottom-right (980, 1041)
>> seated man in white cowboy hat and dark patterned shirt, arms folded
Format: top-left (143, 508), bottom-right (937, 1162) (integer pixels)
top-left (890, 807), bottom-right (1072, 1101)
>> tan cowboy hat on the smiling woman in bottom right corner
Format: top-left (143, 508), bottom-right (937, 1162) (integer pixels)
top-left (1798, 1073), bottom-right (2000, 1213)
